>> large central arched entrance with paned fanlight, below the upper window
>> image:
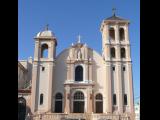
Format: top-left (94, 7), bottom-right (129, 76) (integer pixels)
top-left (73, 91), bottom-right (84, 113)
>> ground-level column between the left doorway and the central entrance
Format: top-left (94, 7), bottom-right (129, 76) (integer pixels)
top-left (64, 85), bottom-right (71, 113)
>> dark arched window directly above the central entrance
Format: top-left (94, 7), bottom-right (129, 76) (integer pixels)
top-left (75, 66), bottom-right (83, 81)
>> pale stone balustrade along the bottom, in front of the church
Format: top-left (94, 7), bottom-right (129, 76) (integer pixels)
top-left (26, 113), bottom-right (132, 120)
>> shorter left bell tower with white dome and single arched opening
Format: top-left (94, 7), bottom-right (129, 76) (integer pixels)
top-left (31, 25), bottom-right (57, 113)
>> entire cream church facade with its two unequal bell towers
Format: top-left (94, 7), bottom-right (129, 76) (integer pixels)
top-left (19, 14), bottom-right (134, 120)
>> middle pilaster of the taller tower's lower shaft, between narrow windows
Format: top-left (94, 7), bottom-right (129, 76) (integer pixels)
top-left (116, 63), bottom-right (123, 113)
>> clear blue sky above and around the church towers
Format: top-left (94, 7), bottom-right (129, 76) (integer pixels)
top-left (18, 0), bottom-right (140, 98)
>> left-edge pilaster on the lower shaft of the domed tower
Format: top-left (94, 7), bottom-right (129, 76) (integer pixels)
top-left (31, 62), bottom-right (38, 113)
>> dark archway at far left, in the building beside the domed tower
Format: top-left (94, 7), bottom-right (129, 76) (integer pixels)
top-left (18, 97), bottom-right (26, 120)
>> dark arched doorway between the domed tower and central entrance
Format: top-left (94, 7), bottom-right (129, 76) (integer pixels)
top-left (55, 93), bottom-right (63, 113)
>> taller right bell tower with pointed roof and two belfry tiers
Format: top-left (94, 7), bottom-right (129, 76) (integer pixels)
top-left (100, 9), bottom-right (134, 117)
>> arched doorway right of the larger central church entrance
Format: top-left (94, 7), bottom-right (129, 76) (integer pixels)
top-left (95, 93), bottom-right (103, 113)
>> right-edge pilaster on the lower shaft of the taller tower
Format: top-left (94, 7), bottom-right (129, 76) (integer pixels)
top-left (127, 63), bottom-right (134, 113)
